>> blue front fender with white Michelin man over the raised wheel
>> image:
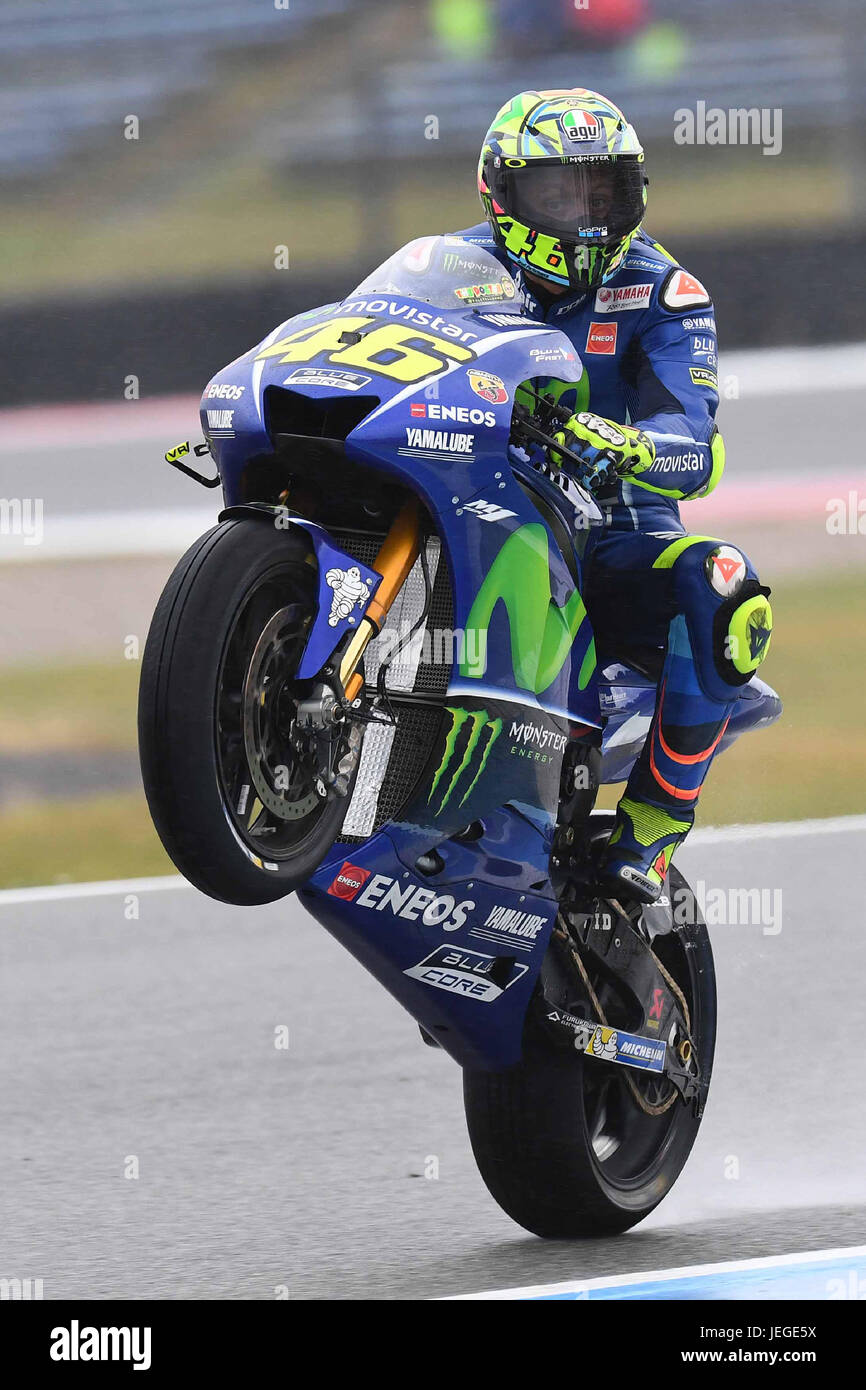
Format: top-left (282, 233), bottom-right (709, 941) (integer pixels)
top-left (220, 502), bottom-right (382, 680)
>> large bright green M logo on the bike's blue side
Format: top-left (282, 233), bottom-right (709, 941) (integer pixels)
top-left (460, 521), bottom-right (595, 695)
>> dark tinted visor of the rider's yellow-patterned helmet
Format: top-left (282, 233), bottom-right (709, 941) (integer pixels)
top-left (488, 154), bottom-right (644, 246)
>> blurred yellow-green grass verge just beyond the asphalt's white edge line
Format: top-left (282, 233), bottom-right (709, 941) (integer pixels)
top-left (0, 573), bottom-right (866, 887)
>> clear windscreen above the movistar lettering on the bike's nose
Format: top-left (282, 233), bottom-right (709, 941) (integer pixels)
top-left (353, 236), bottom-right (520, 313)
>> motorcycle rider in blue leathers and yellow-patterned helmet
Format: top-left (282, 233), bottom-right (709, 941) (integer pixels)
top-left (459, 88), bottom-right (771, 902)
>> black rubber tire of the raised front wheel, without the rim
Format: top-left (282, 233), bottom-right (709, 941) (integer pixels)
top-left (139, 518), bottom-right (349, 906)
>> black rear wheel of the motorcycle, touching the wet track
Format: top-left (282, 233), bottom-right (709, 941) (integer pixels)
top-left (463, 869), bottom-right (716, 1240)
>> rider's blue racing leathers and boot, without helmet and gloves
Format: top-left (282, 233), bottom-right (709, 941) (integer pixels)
top-left (450, 222), bottom-right (771, 898)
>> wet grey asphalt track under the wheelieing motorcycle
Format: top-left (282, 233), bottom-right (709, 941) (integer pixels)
top-left (0, 830), bottom-right (866, 1298)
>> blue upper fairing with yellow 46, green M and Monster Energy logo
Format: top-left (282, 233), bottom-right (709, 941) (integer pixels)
top-left (202, 295), bottom-right (599, 834)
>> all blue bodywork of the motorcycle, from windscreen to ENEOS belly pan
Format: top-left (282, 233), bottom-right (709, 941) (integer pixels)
top-left (202, 238), bottom-right (771, 1068)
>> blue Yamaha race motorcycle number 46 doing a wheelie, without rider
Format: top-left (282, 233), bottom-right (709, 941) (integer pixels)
top-left (139, 236), bottom-right (781, 1237)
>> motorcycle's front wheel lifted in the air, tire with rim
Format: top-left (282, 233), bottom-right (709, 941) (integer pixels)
top-left (139, 518), bottom-right (360, 905)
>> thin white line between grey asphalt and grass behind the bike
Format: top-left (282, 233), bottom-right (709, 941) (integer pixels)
top-left (0, 812), bottom-right (866, 908)
